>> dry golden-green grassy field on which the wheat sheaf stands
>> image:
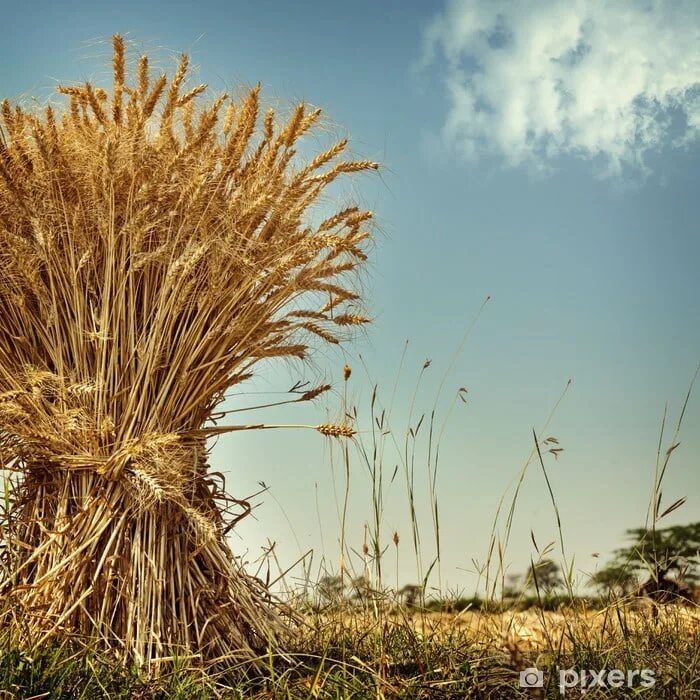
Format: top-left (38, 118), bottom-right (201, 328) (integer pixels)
top-left (0, 602), bottom-right (700, 700)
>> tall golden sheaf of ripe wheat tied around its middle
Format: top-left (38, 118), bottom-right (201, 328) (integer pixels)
top-left (0, 36), bottom-right (376, 663)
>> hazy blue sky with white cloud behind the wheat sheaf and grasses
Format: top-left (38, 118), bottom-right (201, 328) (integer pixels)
top-left (0, 0), bottom-right (700, 594)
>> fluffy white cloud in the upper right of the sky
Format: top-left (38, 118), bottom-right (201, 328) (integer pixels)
top-left (424, 0), bottom-right (700, 174)
